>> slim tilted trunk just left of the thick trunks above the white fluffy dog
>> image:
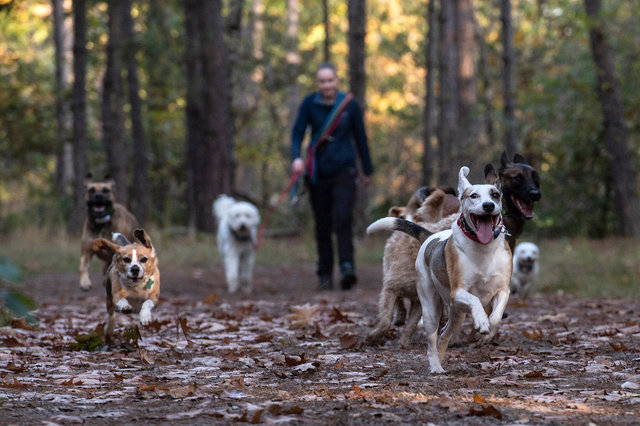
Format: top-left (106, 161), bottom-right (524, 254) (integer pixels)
top-left (122, 0), bottom-right (149, 226)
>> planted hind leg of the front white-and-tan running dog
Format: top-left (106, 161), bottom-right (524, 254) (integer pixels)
top-left (416, 270), bottom-right (444, 374)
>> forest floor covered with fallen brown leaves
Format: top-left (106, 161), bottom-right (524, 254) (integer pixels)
top-left (0, 264), bottom-right (640, 425)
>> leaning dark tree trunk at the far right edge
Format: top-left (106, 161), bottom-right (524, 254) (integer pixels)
top-left (584, 0), bottom-right (640, 237)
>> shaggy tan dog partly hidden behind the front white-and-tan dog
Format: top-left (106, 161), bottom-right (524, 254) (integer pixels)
top-left (367, 187), bottom-right (460, 347)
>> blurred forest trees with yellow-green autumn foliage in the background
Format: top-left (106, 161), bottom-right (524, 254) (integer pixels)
top-left (0, 0), bottom-right (640, 237)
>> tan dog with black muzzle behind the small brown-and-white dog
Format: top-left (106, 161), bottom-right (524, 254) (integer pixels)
top-left (80, 173), bottom-right (139, 290)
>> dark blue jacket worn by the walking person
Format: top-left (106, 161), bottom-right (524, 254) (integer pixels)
top-left (291, 92), bottom-right (373, 178)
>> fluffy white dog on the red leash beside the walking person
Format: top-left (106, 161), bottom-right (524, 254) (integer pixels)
top-left (213, 195), bottom-right (260, 293)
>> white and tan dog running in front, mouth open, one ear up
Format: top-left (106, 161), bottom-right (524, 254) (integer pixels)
top-left (367, 167), bottom-right (512, 373)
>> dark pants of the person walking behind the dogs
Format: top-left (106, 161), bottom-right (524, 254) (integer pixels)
top-left (308, 169), bottom-right (357, 276)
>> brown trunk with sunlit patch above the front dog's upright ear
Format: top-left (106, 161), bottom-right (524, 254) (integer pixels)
top-left (455, 0), bottom-right (479, 165)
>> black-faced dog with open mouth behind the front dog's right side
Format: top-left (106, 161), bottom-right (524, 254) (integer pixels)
top-left (484, 152), bottom-right (542, 252)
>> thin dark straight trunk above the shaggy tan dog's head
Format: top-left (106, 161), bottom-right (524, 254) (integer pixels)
top-left (422, 0), bottom-right (438, 185)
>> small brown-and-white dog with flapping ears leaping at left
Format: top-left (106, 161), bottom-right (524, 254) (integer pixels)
top-left (93, 229), bottom-right (160, 344)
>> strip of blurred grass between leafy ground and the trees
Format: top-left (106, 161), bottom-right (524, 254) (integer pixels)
top-left (0, 228), bottom-right (640, 298)
